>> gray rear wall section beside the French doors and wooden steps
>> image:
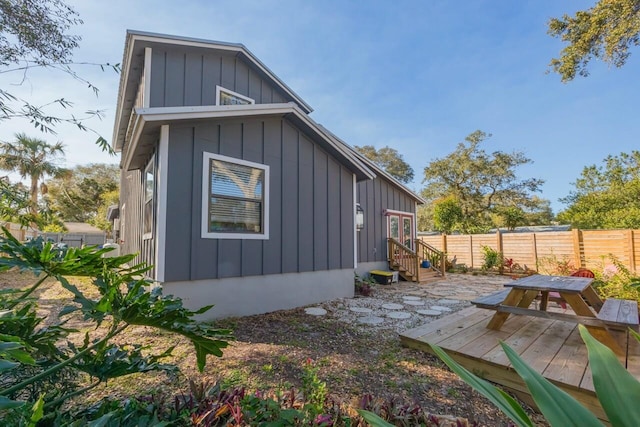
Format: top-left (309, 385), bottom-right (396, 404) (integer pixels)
top-left (356, 177), bottom-right (416, 268)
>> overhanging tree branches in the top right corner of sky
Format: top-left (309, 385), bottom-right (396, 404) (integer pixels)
top-left (548, 0), bottom-right (640, 82)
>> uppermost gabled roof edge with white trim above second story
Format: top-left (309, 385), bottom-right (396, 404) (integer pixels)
top-left (112, 30), bottom-right (313, 150)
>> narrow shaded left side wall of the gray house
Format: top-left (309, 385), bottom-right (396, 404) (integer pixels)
top-left (120, 166), bottom-right (155, 277)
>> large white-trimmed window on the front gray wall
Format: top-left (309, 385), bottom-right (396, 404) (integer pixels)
top-left (202, 152), bottom-right (269, 240)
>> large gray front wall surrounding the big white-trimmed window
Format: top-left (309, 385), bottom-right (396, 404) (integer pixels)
top-left (159, 117), bottom-right (354, 284)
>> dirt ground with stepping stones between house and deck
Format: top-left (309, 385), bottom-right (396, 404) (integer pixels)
top-left (0, 273), bottom-right (544, 426)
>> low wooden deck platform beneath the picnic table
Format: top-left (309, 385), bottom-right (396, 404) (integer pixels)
top-left (400, 307), bottom-right (640, 421)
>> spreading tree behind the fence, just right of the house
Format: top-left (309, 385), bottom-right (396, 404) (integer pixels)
top-left (422, 130), bottom-right (544, 233)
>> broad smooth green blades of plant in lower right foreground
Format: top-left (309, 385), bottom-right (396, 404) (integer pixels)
top-left (424, 325), bottom-right (640, 427)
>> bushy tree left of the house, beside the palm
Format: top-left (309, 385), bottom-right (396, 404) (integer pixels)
top-left (47, 164), bottom-right (120, 229)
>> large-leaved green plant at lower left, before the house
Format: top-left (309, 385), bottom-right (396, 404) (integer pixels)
top-left (0, 229), bottom-right (231, 419)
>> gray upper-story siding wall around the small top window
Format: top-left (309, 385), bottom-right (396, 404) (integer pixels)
top-left (149, 46), bottom-right (292, 107)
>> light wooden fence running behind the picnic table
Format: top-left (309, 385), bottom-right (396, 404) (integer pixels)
top-left (420, 230), bottom-right (640, 274)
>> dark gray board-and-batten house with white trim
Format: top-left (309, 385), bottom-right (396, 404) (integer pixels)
top-left (112, 31), bottom-right (421, 317)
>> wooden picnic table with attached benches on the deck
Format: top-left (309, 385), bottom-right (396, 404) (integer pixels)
top-left (472, 274), bottom-right (639, 355)
